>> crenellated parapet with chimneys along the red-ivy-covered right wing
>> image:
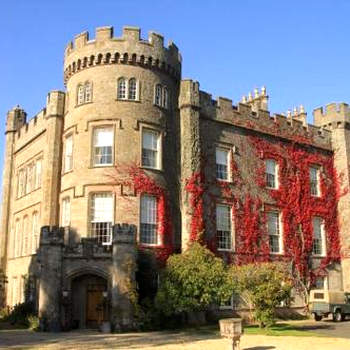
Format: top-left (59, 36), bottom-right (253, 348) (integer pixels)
top-left (180, 80), bottom-right (331, 150)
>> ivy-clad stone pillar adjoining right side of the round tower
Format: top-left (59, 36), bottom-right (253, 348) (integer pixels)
top-left (179, 80), bottom-right (201, 250)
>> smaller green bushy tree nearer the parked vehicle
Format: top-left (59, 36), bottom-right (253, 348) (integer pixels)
top-left (231, 263), bottom-right (292, 328)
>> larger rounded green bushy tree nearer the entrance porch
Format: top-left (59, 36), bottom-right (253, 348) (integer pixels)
top-left (156, 242), bottom-right (233, 315)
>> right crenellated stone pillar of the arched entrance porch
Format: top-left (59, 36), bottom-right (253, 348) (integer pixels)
top-left (111, 224), bottom-right (137, 331)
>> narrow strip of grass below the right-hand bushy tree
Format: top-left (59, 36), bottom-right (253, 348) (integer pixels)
top-left (244, 323), bottom-right (325, 337)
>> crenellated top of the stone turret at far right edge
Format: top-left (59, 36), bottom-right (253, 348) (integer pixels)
top-left (313, 102), bottom-right (350, 127)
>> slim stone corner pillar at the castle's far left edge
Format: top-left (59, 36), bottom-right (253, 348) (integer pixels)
top-left (0, 106), bottom-right (26, 270)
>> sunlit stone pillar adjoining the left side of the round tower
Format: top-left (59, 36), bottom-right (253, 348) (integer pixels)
top-left (41, 91), bottom-right (65, 226)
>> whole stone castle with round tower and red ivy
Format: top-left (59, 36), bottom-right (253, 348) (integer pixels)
top-left (0, 27), bottom-right (350, 330)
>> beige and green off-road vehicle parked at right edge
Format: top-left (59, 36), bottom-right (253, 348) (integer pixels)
top-left (310, 289), bottom-right (350, 322)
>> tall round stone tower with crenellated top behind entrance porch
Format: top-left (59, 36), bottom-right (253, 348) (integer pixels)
top-left (60, 27), bottom-right (181, 250)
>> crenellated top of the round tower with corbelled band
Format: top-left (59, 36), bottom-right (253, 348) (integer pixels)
top-left (64, 26), bottom-right (181, 82)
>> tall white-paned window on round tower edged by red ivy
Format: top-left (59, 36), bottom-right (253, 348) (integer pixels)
top-left (140, 195), bottom-right (158, 244)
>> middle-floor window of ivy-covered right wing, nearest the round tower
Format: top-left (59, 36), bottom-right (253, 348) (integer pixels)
top-left (216, 205), bottom-right (232, 250)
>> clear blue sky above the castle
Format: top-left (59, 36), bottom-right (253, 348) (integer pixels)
top-left (0, 0), bottom-right (350, 189)
